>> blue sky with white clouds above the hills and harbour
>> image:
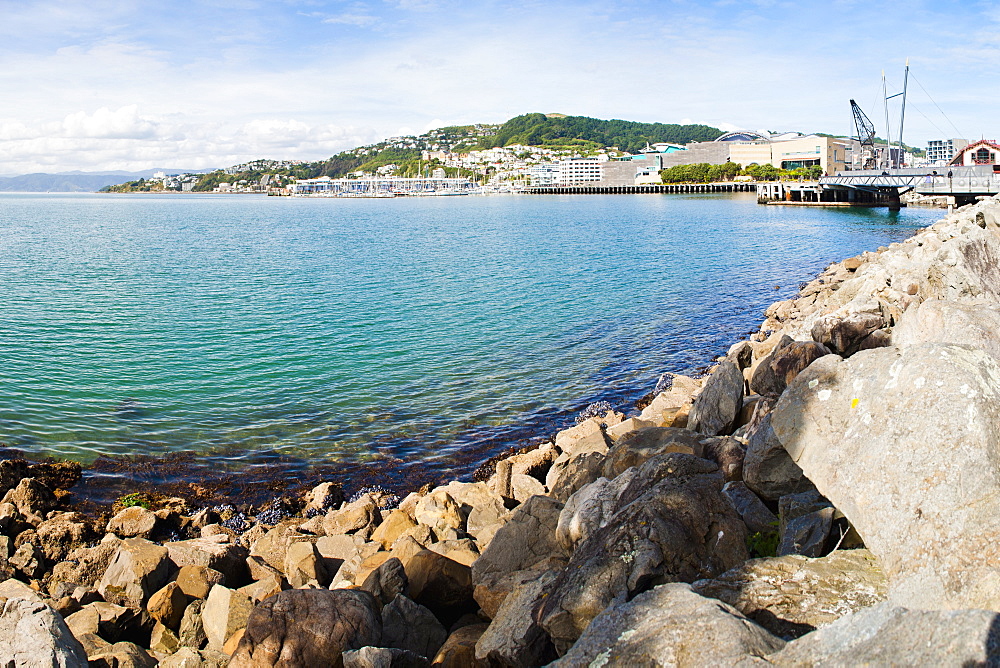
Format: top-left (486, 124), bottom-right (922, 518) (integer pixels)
top-left (0, 0), bottom-right (1000, 175)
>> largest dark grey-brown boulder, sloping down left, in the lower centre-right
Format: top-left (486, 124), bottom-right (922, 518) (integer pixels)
top-left (540, 453), bottom-right (747, 651)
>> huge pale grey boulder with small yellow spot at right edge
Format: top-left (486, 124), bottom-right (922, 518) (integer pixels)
top-left (772, 344), bottom-right (1000, 610)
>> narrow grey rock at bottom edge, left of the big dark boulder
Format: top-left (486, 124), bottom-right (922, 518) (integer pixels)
top-left (476, 571), bottom-right (556, 667)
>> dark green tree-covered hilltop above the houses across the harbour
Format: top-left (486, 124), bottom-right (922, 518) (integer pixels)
top-left (481, 114), bottom-right (722, 153)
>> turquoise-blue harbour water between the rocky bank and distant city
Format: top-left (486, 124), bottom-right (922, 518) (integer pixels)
top-left (0, 194), bottom-right (941, 498)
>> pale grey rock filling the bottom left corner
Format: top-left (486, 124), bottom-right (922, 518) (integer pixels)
top-left (0, 598), bottom-right (87, 668)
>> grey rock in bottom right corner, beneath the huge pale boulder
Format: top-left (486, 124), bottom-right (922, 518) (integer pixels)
top-left (767, 602), bottom-right (1000, 666)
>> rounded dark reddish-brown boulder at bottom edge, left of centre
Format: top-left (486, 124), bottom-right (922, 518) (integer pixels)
top-left (229, 589), bottom-right (382, 668)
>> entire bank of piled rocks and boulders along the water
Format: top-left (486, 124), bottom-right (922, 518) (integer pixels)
top-left (0, 200), bottom-right (1000, 668)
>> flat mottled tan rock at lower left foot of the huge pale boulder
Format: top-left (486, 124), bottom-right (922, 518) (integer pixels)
top-left (691, 550), bottom-right (888, 638)
